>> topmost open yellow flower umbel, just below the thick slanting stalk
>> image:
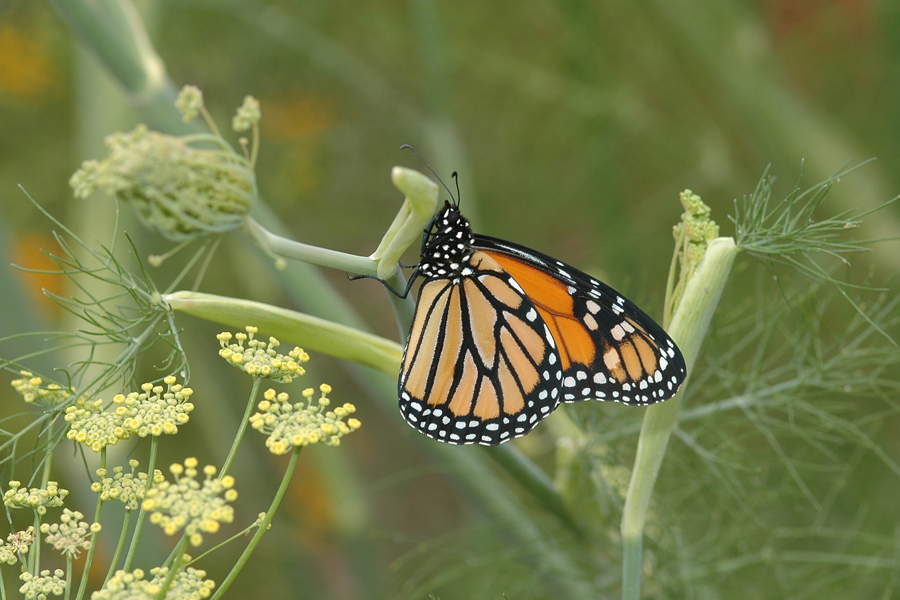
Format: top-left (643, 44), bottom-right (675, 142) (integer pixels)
top-left (216, 325), bottom-right (309, 383)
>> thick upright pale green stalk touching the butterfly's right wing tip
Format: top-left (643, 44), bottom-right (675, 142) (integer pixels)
top-left (621, 238), bottom-right (738, 600)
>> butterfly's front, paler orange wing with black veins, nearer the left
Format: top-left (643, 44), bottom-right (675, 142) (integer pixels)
top-left (398, 252), bottom-right (563, 445)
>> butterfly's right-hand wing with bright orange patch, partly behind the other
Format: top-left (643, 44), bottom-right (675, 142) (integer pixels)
top-left (473, 235), bottom-right (686, 405)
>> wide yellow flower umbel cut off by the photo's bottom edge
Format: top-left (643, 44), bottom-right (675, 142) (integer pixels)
top-left (91, 555), bottom-right (216, 600)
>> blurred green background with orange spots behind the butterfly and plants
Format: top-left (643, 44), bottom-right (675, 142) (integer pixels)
top-left (0, 0), bottom-right (900, 599)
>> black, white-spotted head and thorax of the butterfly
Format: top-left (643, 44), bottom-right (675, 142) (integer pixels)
top-left (419, 202), bottom-right (475, 280)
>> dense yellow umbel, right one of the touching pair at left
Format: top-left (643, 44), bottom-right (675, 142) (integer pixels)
top-left (113, 375), bottom-right (194, 437)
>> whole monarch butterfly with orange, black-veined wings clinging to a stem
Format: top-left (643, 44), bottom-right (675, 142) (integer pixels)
top-left (398, 201), bottom-right (686, 446)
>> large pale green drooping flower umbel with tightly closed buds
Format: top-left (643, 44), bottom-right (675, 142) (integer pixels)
top-left (69, 125), bottom-right (257, 241)
